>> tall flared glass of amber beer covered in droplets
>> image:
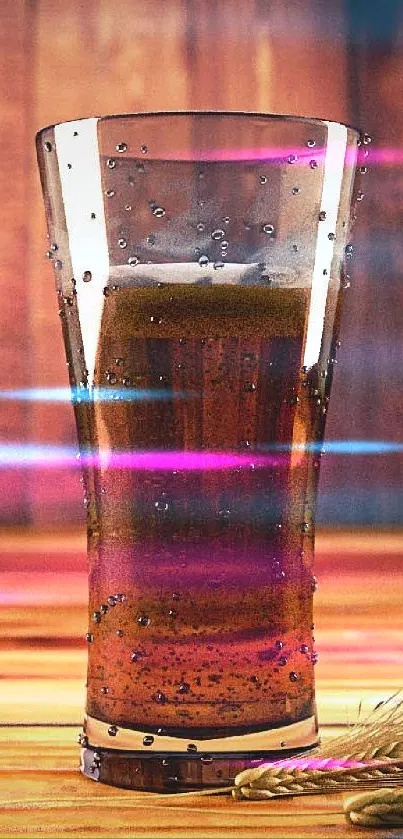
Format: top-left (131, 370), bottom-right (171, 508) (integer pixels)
top-left (37, 111), bottom-right (361, 792)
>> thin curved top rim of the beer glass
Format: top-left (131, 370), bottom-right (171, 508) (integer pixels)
top-left (36, 110), bottom-right (363, 139)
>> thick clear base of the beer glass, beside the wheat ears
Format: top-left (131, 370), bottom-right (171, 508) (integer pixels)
top-left (80, 717), bottom-right (318, 793)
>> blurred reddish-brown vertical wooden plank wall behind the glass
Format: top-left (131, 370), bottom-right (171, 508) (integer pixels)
top-left (0, 0), bottom-right (403, 530)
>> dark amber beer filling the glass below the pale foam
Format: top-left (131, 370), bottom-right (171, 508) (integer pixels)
top-left (70, 284), bottom-right (338, 788)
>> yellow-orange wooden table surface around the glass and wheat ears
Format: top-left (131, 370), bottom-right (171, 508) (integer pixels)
top-left (0, 532), bottom-right (403, 839)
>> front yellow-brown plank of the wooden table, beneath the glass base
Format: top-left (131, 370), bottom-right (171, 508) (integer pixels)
top-left (0, 726), bottom-right (394, 839)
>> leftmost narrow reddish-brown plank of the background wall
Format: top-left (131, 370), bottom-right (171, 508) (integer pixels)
top-left (0, 0), bottom-right (31, 524)
